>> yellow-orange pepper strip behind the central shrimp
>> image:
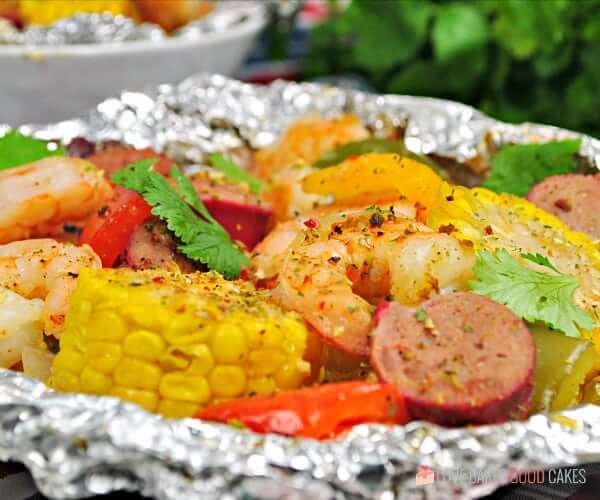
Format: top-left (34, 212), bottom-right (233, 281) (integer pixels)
top-left (302, 153), bottom-right (442, 218)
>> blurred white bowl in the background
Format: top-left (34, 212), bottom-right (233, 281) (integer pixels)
top-left (0, 9), bottom-right (266, 126)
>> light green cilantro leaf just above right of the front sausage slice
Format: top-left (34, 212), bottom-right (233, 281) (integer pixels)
top-left (469, 249), bottom-right (594, 337)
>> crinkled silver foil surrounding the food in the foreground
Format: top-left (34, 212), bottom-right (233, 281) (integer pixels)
top-left (0, 75), bottom-right (600, 500)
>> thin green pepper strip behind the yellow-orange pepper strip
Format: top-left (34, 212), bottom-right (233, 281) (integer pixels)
top-left (313, 138), bottom-right (440, 173)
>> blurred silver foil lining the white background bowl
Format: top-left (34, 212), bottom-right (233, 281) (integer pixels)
top-left (0, 1), bottom-right (262, 47)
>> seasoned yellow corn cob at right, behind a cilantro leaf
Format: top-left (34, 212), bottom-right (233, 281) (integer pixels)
top-left (427, 183), bottom-right (600, 350)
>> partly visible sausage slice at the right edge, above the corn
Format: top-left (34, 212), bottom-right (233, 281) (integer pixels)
top-left (527, 174), bottom-right (600, 238)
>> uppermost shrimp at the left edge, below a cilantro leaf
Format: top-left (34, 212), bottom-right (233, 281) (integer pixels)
top-left (0, 157), bottom-right (112, 243)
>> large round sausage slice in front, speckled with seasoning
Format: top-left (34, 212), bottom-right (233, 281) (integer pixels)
top-left (371, 292), bottom-right (536, 425)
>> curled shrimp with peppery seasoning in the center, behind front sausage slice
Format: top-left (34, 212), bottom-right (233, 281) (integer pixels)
top-left (255, 210), bottom-right (475, 356)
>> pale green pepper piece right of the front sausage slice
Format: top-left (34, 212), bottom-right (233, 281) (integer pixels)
top-left (530, 325), bottom-right (600, 412)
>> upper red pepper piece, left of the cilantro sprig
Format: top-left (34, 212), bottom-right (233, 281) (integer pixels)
top-left (79, 188), bottom-right (152, 267)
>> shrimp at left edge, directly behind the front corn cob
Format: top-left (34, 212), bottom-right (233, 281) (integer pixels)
top-left (0, 239), bottom-right (102, 337)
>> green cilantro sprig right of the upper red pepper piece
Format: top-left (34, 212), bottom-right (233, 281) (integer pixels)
top-left (112, 159), bottom-right (248, 278)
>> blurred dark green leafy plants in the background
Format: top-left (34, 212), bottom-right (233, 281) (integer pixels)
top-left (270, 0), bottom-right (600, 136)
